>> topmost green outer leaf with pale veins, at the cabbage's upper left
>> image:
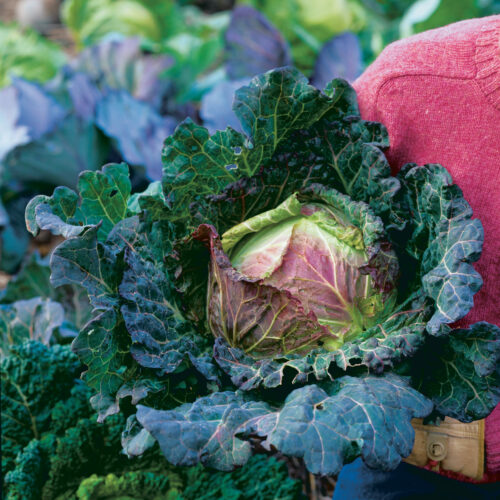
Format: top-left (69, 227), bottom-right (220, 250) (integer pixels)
top-left (163, 69), bottom-right (339, 227)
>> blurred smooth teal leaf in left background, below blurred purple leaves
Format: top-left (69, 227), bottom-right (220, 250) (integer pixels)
top-left (4, 115), bottom-right (108, 187)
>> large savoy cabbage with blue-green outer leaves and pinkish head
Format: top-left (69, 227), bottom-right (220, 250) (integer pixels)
top-left (26, 68), bottom-right (500, 475)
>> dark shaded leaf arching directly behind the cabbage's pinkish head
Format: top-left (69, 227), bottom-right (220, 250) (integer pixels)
top-left (181, 77), bottom-right (403, 240)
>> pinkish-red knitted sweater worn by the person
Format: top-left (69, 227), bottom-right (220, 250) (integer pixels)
top-left (354, 15), bottom-right (500, 477)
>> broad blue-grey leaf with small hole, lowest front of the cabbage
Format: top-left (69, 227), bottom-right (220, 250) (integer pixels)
top-left (245, 375), bottom-right (432, 475)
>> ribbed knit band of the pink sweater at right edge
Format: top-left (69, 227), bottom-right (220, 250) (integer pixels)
top-left (475, 16), bottom-right (500, 109)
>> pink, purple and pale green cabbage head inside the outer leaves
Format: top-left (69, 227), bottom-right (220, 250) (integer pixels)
top-left (199, 190), bottom-right (398, 357)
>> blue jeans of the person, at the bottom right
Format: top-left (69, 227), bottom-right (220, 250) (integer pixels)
top-left (333, 458), bottom-right (500, 500)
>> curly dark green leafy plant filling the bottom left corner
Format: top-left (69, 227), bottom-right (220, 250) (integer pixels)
top-left (0, 341), bottom-right (301, 500)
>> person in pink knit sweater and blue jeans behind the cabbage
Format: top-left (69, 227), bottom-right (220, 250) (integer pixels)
top-left (333, 15), bottom-right (500, 500)
